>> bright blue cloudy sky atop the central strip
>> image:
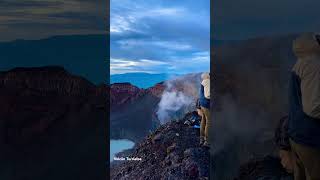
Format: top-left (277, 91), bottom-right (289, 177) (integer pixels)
top-left (110, 0), bottom-right (210, 74)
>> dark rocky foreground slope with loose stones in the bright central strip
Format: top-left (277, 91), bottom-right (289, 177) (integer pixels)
top-left (111, 115), bottom-right (209, 180)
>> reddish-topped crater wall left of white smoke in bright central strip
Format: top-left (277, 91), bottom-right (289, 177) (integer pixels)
top-left (110, 83), bottom-right (164, 142)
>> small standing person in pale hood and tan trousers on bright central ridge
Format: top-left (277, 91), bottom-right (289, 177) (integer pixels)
top-left (199, 73), bottom-right (210, 146)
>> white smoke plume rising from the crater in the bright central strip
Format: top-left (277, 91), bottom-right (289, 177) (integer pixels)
top-left (157, 74), bottom-right (200, 124)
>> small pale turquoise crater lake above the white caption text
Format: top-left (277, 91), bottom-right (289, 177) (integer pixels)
top-left (110, 139), bottom-right (134, 162)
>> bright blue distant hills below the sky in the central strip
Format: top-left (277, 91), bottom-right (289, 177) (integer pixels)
top-left (110, 73), bottom-right (177, 89)
